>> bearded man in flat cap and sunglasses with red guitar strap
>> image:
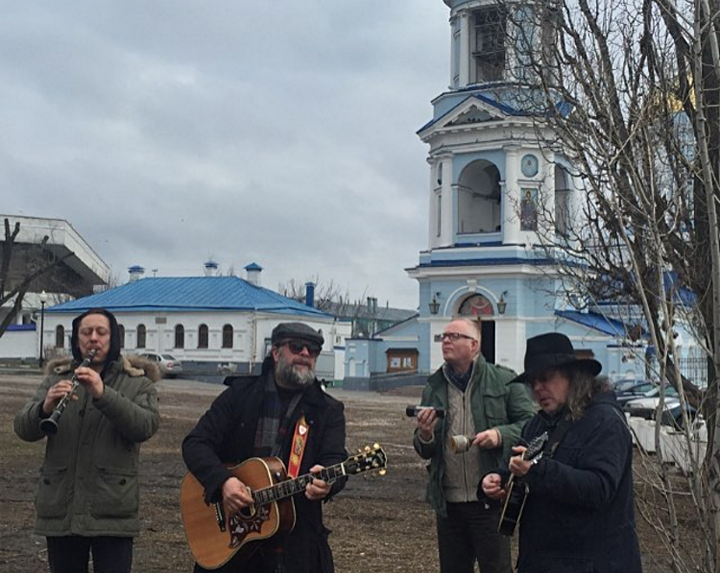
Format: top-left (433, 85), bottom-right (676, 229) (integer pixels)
top-left (182, 322), bottom-right (347, 573)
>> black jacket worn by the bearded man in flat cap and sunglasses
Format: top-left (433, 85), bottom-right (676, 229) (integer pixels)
top-left (182, 358), bottom-right (347, 573)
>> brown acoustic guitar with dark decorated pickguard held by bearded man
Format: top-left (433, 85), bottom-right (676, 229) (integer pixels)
top-left (180, 444), bottom-right (387, 569)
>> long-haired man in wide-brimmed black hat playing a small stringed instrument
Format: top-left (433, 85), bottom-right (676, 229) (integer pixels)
top-left (479, 332), bottom-right (642, 573)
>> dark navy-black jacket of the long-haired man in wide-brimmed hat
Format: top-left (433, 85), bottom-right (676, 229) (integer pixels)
top-left (518, 393), bottom-right (642, 573)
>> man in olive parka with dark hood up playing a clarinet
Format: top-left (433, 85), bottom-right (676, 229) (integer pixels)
top-left (15, 309), bottom-right (160, 573)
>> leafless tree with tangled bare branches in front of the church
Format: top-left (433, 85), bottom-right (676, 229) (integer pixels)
top-left (484, 0), bottom-right (720, 573)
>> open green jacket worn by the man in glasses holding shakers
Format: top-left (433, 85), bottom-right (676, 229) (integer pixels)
top-left (413, 355), bottom-right (536, 517)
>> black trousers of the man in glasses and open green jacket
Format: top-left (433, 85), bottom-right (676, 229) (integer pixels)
top-left (437, 501), bottom-right (512, 573)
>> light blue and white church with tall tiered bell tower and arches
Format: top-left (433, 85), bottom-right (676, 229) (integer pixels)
top-left (345, 0), bottom-right (696, 379)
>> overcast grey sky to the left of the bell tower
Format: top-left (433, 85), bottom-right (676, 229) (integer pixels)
top-left (0, 0), bottom-right (450, 308)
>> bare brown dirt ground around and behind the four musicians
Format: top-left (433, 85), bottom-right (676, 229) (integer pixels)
top-left (0, 375), bottom-right (696, 573)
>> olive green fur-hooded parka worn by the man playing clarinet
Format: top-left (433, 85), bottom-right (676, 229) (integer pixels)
top-left (15, 357), bottom-right (160, 537)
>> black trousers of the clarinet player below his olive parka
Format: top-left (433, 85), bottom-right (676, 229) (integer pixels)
top-left (47, 535), bottom-right (133, 573)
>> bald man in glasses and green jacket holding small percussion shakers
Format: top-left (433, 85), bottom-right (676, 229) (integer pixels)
top-left (413, 318), bottom-right (535, 573)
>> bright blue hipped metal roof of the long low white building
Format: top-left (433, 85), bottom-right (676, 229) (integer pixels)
top-left (46, 277), bottom-right (331, 318)
